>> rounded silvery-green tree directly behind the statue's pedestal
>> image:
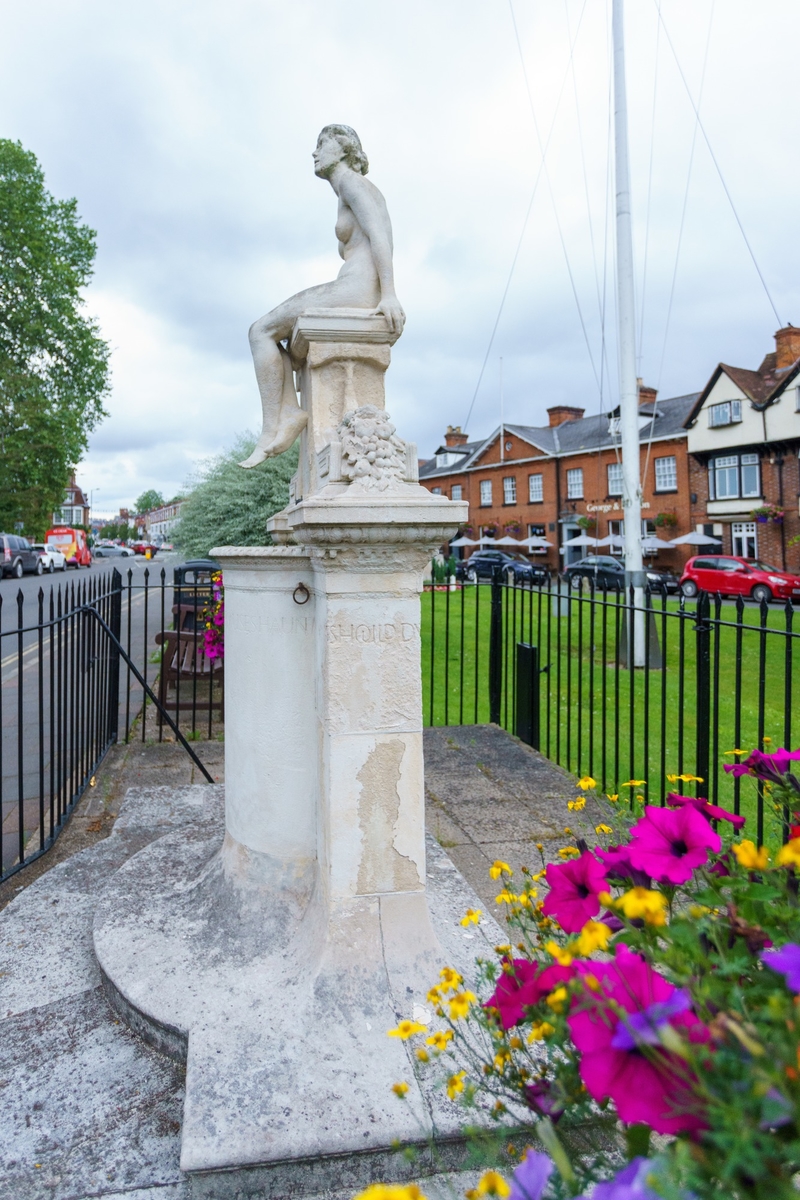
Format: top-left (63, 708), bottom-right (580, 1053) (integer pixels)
top-left (173, 433), bottom-right (297, 557)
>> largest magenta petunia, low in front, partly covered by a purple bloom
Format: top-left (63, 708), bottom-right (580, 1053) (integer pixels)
top-left (567, 946), bottom-right (709, 1134)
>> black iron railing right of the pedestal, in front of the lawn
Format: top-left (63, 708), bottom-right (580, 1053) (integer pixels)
top-left (422, 577), bottom-right (800, 836)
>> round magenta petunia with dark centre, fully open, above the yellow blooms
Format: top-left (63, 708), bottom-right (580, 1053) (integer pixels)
top-left (631, 804), bottom-right (722, 883)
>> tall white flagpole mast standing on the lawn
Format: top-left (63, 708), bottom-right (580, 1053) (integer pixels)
top-left (612, 0), bottom-right (645, 667)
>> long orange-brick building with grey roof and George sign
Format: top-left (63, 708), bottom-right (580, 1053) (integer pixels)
top-left (420, 386), bottom-right (698, 570)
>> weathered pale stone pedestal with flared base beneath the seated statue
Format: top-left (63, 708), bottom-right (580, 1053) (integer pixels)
top-left (95, 311), bottom-right (467, 1180)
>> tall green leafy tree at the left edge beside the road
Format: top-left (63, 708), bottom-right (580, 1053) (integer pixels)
top-left (0, 138), bottom-right (109, 536)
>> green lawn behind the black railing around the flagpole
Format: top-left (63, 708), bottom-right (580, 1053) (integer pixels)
top-left (422, 586), bottom-right (800, 835)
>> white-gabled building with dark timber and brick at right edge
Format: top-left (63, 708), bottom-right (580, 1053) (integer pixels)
top-left (686, 325), bottom-right (800, 570)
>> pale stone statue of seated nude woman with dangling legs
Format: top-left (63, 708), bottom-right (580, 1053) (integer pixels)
top-left (241, 125), bottom-right (405, 467)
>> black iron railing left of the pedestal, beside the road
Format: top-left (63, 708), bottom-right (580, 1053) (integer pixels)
top-left (0, 569), bottom-right (223, 880)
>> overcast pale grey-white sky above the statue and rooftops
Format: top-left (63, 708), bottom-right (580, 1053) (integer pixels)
top-left (0, 0), bottom-right (800, 514)
